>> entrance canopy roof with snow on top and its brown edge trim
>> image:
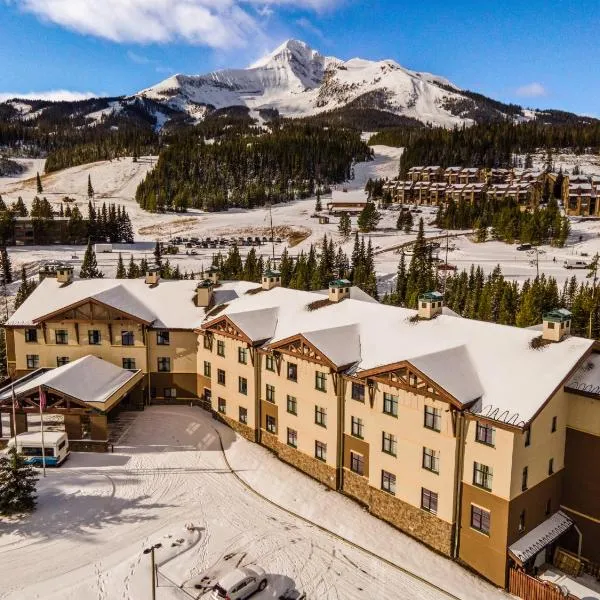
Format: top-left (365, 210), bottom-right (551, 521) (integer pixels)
top-left (0, 355), bottom-right (143, 412)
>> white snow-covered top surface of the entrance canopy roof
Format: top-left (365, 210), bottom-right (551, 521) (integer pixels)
top-left (0, 355), bottom-right (136, 402)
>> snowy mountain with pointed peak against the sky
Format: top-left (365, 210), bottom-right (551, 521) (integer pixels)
top-left (0, 40), bottom-right (589, 130)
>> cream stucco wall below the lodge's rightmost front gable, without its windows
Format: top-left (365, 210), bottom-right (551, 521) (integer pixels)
top-left (344, 383), bottom-right (456, 523)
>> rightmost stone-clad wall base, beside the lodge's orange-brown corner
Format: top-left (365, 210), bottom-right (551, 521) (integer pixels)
top-left (343, 469), bottom-right (454, 556)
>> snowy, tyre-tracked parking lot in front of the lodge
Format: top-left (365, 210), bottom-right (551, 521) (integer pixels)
top-left (0, 406), bottom-right (509, 600)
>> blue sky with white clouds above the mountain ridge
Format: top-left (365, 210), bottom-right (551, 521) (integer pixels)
top-left (0, 0), bottom-right (600, 116)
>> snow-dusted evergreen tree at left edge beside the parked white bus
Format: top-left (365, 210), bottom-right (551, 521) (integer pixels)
top-left (0, 447), bottom-right (37, 515)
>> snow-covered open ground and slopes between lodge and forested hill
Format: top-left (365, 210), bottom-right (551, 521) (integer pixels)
top-left (0, 146), bottom-right (600, 293)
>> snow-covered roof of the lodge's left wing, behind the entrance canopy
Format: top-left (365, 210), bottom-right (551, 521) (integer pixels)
top-left (6, 278), bottom-right (256, 329)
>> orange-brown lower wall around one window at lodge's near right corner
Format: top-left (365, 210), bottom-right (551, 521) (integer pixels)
top-left (459, 483), bottom-right (509, 587)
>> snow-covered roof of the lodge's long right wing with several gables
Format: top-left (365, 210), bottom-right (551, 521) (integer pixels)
top-left (204, 287), bottom-right (592, 426)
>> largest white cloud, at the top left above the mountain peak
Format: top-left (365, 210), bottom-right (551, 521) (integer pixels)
top-left (9, 0), bottom-right (340, 49)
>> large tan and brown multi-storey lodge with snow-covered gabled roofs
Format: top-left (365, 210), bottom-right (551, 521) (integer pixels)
top-left (0, 269), bottom-right (600, 587)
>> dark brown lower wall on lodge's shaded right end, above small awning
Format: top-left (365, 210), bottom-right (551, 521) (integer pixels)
top-left (508, 469), bottom-right (564, 546)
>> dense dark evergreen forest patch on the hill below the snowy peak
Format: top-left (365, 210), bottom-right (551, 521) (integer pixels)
top-left (136, 122), bottom-right (372, 212)
